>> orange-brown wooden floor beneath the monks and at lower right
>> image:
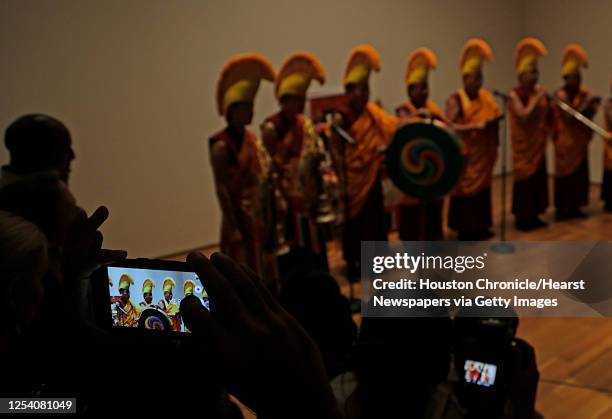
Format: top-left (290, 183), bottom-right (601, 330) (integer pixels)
top-left (173, 178), bottom-right (612, 419)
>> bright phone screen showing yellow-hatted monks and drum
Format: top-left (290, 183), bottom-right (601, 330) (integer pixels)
top-left (107, 266), bottom-right (210, 333)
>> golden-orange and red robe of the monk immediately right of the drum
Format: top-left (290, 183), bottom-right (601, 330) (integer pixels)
top-left (451, 89), bottom-right (501, 196)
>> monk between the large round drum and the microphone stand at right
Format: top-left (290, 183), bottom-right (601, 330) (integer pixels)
top-left (446, 39), bottom-right (502, 240)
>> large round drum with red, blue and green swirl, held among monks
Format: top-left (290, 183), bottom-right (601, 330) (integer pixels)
top-left (385, 122), bottom-right (464, 201)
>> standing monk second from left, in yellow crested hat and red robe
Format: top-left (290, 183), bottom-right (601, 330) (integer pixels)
top-left (261, 52), bottom-right (328, 278)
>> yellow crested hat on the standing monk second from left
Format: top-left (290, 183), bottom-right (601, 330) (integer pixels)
top-left (274, 52), bottom-right (325, 99)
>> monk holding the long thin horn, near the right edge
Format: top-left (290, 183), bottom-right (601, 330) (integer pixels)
top-left (553, 44), bottom-right (601, 220)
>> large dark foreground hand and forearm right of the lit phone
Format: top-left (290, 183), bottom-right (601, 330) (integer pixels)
top-left (181, 253), bottom-right (340, 418)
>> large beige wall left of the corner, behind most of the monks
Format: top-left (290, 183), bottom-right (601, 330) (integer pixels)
top-left (0, 0), bottom-right (524, 256)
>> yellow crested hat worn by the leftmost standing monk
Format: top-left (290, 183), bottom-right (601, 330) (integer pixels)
top-left (217, 54), bottom-right (275, 116)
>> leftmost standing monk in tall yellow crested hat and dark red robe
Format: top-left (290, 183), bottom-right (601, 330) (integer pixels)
top-left (209, 54), bottom-right (275, 276)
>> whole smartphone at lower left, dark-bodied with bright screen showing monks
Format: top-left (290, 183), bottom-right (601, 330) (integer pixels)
top-left (93, 259), bottom-right (210, 335)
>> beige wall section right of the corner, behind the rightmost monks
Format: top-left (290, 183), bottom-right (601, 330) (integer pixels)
top-left (525, 0), bottom-right (612, 183)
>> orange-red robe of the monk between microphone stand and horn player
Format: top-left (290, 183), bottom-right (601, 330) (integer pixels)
top-left (508, 87), bottom-right (552, 182)
